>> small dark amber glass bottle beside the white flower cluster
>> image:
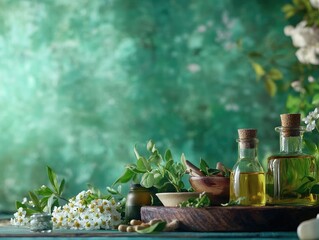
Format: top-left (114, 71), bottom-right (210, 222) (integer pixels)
top-left (125, 184), bottom-right (152, 222)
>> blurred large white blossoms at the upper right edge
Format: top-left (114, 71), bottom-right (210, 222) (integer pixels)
top-left (284, 21), bottom-right (319, 65)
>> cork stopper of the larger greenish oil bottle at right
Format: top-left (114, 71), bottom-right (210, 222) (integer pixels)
top-left (280, 113), bottom-right (300, 137)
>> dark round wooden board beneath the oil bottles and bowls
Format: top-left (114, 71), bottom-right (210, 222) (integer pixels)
top-left (141, 206), bottom-right (319, 232)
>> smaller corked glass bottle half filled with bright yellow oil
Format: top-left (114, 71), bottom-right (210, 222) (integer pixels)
top-left (230, 129), bottom-right (266, 206)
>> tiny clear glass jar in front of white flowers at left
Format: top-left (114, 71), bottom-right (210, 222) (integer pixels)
top-left (30, 213), bottom-right (53, 232)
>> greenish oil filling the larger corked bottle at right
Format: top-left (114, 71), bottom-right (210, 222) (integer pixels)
top-left (266, 155), bottom-right (318, 206)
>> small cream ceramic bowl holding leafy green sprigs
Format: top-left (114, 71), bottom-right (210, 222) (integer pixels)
top-left (156, 192), bottom-right (200, 207)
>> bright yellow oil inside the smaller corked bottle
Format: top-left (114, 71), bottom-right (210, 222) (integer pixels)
top-left (230, 172), bottom-right (266, 206)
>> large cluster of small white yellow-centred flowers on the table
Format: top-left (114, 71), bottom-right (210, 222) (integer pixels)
top-left (52, 190), bottom-right (121, 230)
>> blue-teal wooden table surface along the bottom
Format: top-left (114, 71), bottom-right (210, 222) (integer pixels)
top-left (0, 216), bottom-right (298, 240)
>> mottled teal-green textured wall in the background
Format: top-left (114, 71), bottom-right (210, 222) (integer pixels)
top-left (0, 0), bottom-right (290, 210)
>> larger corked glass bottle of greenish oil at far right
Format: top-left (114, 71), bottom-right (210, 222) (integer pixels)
top-left (266, 114), bottom-right (317, 206)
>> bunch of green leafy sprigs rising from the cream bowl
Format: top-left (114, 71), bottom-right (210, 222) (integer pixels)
top-left (114, 140), bottom-right (186, 192)
